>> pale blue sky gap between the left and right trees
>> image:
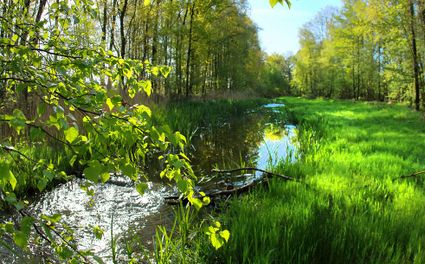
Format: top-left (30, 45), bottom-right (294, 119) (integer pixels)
top-left (249, 0), bottom-right (342, 54)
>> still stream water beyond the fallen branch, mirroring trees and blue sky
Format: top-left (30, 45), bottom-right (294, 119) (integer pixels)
top-left (190, 104), bottom-right (296, 175)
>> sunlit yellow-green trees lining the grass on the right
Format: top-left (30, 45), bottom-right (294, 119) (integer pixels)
top-left (293, 0), bottom-right (425, 109)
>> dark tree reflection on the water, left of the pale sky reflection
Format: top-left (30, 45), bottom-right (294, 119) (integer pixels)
top-left (191, 113), bottom-right (270, 172)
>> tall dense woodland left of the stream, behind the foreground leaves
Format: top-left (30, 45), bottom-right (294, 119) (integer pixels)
top-left (0, 0), bottom-right (288, 107)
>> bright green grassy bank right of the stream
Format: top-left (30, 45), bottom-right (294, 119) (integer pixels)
top-left (207, 98), bottom-right (425, 263)
